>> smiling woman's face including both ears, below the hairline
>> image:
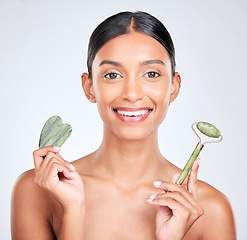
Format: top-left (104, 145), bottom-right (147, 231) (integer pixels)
top-left (82, 32), bottom-right (180, 140)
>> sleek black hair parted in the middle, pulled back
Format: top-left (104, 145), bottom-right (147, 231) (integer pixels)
top-left (87, 12), bottom-right (176, 78)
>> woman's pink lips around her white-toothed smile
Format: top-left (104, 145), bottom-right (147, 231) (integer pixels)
top-left (113, 107), bottom-right (153, 123)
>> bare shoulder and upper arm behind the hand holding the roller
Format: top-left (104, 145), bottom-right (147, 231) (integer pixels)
top-left (198, 181), bottom-right (236, 240)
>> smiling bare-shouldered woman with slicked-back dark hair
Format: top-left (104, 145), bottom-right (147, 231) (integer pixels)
top-left (12, 12), bottom-right (235, 240)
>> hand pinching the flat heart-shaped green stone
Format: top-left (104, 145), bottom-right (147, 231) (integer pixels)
top-left (33, 147), bottom-right (84, 210)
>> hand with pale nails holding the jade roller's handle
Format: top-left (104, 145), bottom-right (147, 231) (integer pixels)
top-left (148, 159), bottom-right (204, 240)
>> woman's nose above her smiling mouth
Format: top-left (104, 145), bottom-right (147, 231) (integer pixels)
top-left (121, 77), bottom-right (143, 102)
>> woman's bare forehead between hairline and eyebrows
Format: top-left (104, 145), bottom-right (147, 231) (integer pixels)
top-left (93, 32), bottom-right (170, 66)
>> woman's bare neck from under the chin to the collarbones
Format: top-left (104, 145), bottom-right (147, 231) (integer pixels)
top-left (91, 126), bottom-right (164, 185)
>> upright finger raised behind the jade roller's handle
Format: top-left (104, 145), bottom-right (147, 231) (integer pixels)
top-left (187, 158), bottom-right (200, 200)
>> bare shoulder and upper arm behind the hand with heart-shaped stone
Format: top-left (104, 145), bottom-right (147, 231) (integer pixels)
top-left (11, 169), bottom-right (54, 239)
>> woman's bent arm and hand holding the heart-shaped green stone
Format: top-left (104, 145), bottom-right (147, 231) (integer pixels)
top-left (11, 147), bottom-right (85, 240)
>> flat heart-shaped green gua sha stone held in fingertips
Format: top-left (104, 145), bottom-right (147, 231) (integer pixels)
top-left (39, 116), bottom-right (72, 148)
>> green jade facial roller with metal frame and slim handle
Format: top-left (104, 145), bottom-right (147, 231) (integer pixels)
top-left (176, 122), bottom-right (223, 185)
